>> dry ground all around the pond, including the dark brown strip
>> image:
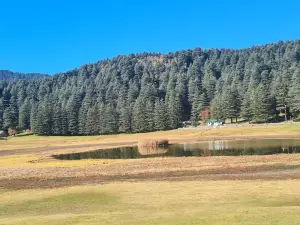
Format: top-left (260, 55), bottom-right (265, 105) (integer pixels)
top-left (0, 124), bottom-right (300, 189)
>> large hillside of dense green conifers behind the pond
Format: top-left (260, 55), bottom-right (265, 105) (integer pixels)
top-left (0, 40), bottom-right (300, 135)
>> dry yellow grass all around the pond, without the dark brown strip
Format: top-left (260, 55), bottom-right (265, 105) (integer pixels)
top-left (0, 124), bottom-right (300, 187)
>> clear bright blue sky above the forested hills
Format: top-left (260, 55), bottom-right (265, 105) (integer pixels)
top-left (0, 0), bottom-right (300, 74)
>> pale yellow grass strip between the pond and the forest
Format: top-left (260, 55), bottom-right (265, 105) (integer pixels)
top-left (0, 123), bottom-right (300, 153)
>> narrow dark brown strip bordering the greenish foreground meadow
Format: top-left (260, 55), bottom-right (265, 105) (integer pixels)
top-left (0, 167), bottom-right (300, 189)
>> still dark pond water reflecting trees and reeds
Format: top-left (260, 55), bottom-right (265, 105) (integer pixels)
top-left (53, 139), bottom-right (300, 160)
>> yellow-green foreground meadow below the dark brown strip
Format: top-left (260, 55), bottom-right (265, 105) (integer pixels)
top-left (0, 180), bottom-right (300, 225)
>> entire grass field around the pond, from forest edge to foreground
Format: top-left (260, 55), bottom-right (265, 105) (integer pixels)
top-left (0, 124), bottom-right (300, 224)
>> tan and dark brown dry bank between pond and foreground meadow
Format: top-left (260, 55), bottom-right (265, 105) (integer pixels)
top-left (0, 154), bottom-right (300, 189)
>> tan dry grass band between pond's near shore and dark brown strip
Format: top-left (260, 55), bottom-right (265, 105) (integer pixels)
top-left (0, 154), bottom-right (300, 182)
